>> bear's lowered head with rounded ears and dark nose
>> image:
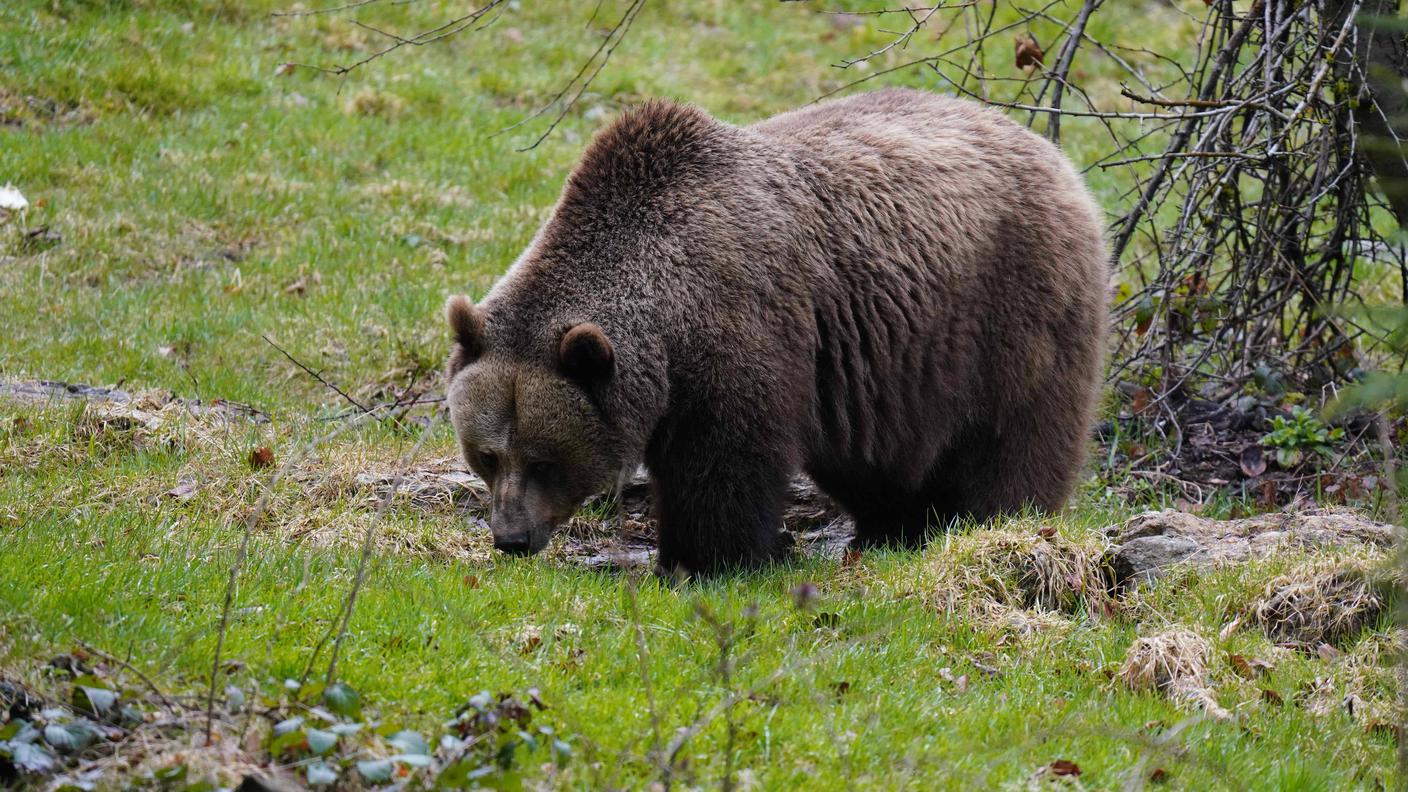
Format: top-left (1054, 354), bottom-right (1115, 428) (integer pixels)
top-left (445, 296), bottom-right (627, 555)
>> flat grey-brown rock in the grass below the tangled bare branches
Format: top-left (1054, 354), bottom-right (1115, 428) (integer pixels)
top-left (1105, 509), bottom-right (1394, 585)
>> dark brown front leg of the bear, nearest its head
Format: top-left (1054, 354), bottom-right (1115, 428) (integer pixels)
top-left (650, 433), bottom-right (791, 576)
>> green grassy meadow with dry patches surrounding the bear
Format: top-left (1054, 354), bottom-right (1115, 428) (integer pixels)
top-left (0, 0), bottom-right (1402, 789)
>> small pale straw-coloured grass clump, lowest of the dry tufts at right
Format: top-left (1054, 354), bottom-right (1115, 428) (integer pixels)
top-left (1117, 630), bottom-right (1231, 720)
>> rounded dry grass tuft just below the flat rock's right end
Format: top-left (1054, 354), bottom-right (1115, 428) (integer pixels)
top-left (1252, 568), bottom-right (1385, 651)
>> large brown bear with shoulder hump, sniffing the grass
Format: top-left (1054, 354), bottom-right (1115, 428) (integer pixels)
top-left (446, 90), bottom-right (1108, 572)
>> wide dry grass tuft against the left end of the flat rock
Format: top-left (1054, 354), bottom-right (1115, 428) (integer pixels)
top-left (929, 526), bottom-right (1115, 614)
